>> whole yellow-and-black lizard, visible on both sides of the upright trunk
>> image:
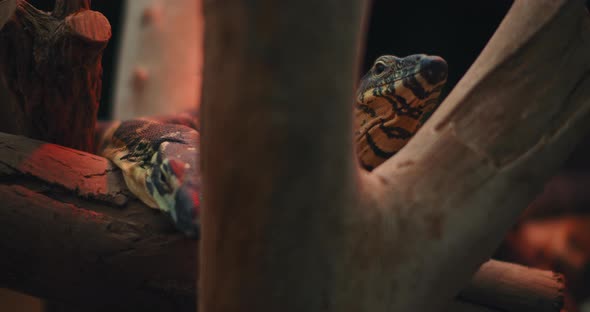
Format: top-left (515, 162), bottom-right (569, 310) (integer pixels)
top-left (97, 54), bottom-right (447, 237)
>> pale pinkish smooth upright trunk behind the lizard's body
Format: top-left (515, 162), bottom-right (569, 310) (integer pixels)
top-left (113, 0), bottom-right (204, 119)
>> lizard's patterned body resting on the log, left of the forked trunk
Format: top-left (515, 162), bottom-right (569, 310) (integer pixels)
top-left (99, 114), bottom-right (201, 237)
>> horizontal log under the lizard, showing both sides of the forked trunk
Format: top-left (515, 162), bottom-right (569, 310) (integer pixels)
top-left (0, 134), bottom-right (563, 312)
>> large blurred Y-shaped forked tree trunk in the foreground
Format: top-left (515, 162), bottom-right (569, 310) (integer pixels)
top-left (199, 0), bottom-right (590, 312)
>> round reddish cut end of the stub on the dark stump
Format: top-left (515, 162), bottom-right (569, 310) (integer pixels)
top-left (65, 10), bottom-right (111, 44)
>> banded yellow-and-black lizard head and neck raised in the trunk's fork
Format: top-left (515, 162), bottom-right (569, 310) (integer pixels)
top-left (354, 54), bottom-right (448, 170)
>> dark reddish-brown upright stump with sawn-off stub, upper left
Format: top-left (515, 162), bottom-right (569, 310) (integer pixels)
top-left (0, 0), bottom-right (111, 151)
